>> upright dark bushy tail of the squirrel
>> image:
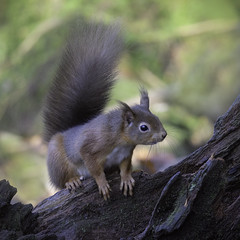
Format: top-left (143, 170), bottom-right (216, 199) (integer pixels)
top-left (43, 22), bottom-right (123, 142)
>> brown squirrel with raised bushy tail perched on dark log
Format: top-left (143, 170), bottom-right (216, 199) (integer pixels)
top-left (43, 23), bottom-right (167, 200)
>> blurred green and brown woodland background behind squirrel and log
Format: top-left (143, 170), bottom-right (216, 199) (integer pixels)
top-left (0, 0), bottom-right (240, 205)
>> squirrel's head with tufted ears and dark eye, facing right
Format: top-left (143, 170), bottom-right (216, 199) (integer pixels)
top-left (120, 90), bottom-right (167, 145)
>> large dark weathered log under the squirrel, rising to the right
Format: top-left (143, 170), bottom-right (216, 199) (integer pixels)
top-left (0, 95), bottom-right (240, 240)
